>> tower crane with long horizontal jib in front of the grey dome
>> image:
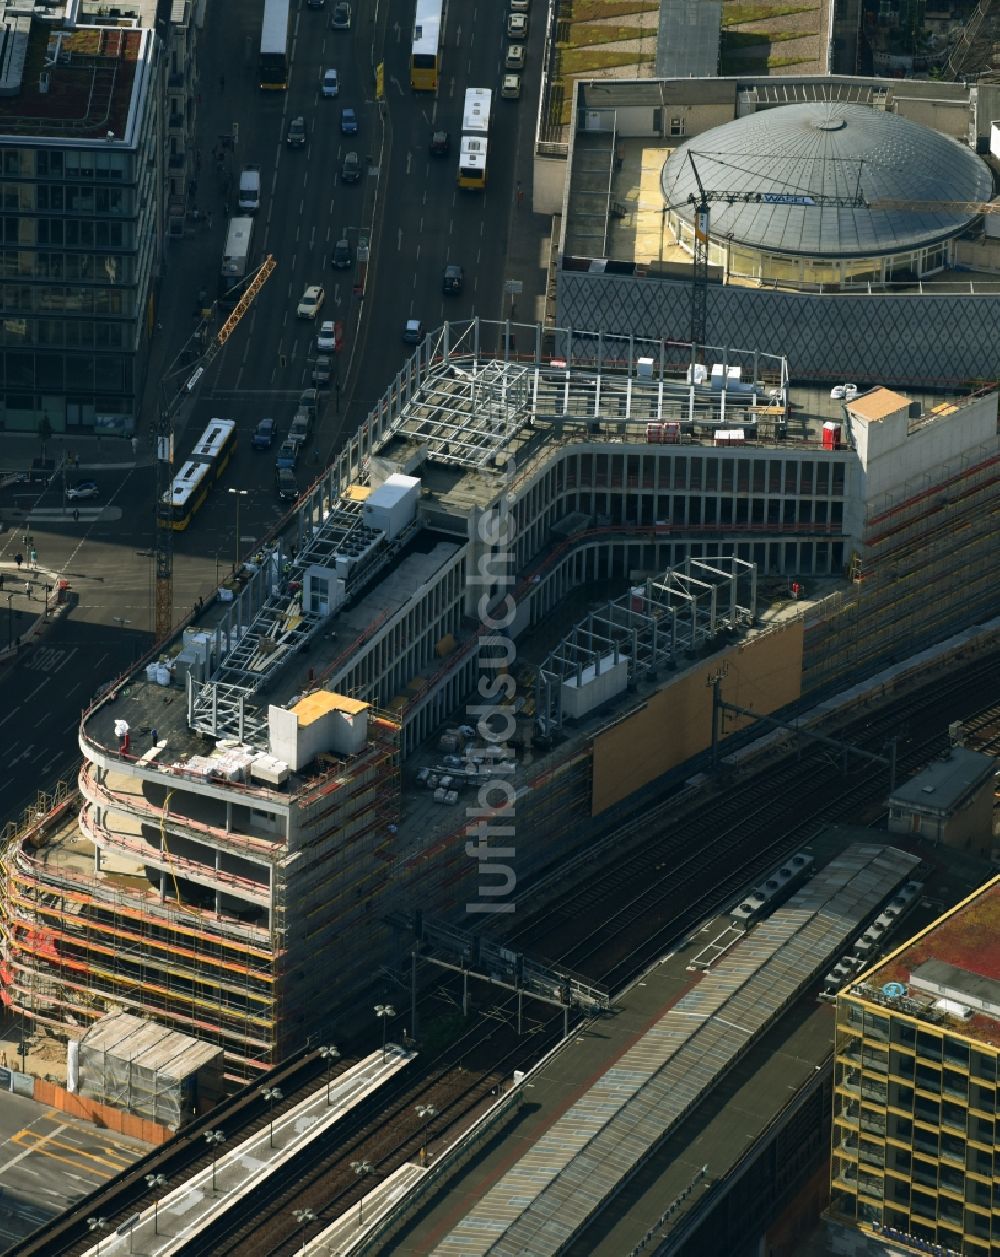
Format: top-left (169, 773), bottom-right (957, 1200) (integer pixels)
top-left (673, 157), bottom-right (1000, 348)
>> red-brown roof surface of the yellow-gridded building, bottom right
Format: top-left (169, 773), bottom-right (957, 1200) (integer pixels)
top-left (864, 876), bottom-right (1000, 1047)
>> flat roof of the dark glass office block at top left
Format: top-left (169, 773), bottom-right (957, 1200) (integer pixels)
top-left (0, 10), bottom-right (152, 143)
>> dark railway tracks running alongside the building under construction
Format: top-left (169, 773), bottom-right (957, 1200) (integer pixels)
top-left (15, 656), bottom-right (1000, 1257)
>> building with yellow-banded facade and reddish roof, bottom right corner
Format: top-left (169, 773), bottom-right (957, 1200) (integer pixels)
top-left (830, 879), bottom-right (1000, 1257)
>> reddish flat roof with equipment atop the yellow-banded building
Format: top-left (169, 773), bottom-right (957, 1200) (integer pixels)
top-left (849, 877), bottom-right (1000, 1047)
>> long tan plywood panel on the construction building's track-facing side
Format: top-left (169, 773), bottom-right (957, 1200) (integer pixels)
top-left (590, 620), bottom-right (803, 816)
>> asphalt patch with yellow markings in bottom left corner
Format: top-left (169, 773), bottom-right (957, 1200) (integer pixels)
top-left (0, 1092), bottom-right (148, 1252)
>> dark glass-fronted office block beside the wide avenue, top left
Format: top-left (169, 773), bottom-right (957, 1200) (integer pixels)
top-left (0, 0), bottom-right (173, 435)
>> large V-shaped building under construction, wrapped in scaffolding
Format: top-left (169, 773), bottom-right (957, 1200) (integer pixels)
top-left (0, 321), bottom-right (1000, 1085)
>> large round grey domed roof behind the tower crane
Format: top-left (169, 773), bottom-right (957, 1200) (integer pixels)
top-left (661, 102), bottom-right (992, 258)
